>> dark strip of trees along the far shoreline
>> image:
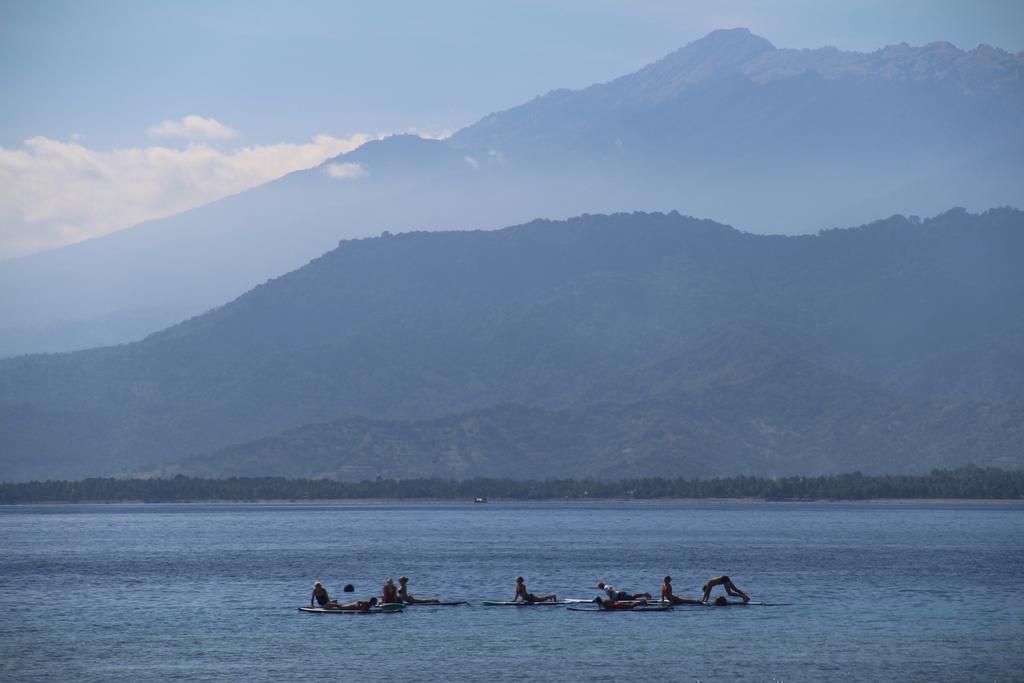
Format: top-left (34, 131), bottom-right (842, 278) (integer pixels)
top-left (0, 466), bottom-right (1024, 505)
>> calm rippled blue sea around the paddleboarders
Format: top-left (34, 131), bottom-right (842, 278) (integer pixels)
top-left (0, 502), bottom-right (1024, 681)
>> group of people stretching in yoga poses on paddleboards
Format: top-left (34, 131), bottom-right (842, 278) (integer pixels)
top-left (309, 575), bottom-right (751, 609)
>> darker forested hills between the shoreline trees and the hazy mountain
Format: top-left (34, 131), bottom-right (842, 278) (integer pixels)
top-left (0, 209), bottom-right (1024, 480)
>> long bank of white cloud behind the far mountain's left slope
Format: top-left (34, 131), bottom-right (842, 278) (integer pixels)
top-left (0, 129), bottom-right (379, 258)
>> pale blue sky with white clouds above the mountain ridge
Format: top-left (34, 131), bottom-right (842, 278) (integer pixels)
top-left (0, 0), bottom-right (1024, 258)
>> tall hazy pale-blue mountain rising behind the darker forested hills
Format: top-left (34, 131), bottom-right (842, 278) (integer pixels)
top-left (0, 29), bottom-right (1024, 358)
